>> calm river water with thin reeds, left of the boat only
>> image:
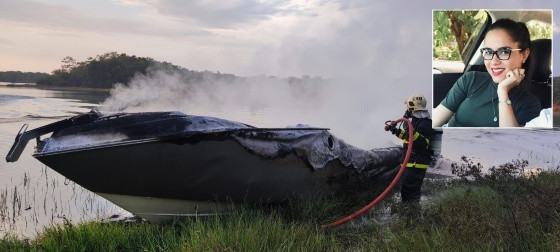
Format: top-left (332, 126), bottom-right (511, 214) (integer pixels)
top-left (0, 84), bottom-right (130, 238)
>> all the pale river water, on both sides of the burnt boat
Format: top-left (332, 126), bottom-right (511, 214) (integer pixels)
top-left (0, 83), bottom-right (560, 238)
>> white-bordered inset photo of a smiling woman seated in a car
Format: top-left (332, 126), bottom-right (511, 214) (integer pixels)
top-left (432, 10), bottom-right (553, 128)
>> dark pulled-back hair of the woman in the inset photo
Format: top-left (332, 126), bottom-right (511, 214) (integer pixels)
top-left (486, 18), bottom-right (533, 88)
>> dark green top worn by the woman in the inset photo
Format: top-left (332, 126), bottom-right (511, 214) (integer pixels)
top-left (441, 72), bottom-right (541, 127)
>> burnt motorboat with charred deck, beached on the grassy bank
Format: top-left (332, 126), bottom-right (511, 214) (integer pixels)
top-left (6, 109), bottom-right (402, 222)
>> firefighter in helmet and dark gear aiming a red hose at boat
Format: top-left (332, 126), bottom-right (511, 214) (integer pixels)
top-left (389, 94), bottom-right (434, 203)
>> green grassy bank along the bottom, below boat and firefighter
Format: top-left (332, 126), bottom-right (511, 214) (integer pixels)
top-left (0, 158), bottom-right (560, 251)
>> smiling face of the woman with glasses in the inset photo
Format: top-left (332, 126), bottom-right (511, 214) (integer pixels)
top-left (484, 29), bottom-right (529, 83)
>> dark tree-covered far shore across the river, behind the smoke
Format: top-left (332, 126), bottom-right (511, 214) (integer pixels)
top-left (0, 52), bottom-right (322, 89)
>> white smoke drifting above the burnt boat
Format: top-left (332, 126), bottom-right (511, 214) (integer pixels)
top-left (101, 68), bottom-right (404, 149)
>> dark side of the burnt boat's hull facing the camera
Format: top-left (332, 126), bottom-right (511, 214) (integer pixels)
top-left (35, 139), bottom-right (358, 202)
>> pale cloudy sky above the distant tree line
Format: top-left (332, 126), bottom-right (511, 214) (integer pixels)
top-left (0, 0), bottom-right (560, 78)
